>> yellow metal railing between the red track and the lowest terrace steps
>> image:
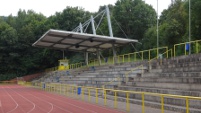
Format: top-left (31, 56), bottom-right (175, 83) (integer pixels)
top-left (35, 83), bottom-right (201, 113)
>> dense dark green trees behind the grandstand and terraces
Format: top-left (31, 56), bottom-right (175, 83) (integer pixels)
top-left (0, 0), bottom-right (201, 81)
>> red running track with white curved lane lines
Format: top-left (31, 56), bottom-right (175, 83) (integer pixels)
top-left (0, 85), bottom-right (123, 113)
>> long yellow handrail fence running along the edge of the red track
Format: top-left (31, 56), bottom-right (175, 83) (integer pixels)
top-left (33, 83), bottom-right (201, 113)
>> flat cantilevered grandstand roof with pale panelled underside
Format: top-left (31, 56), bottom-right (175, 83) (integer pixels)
top-left (33, 29), bottom-right (138, 52)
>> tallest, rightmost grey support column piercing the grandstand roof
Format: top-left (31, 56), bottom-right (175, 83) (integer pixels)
top-left (105, 6), bottom-right (117, 64)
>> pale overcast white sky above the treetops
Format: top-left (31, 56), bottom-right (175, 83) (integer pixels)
top-left (0, 0), bottom-right (171, 17)
